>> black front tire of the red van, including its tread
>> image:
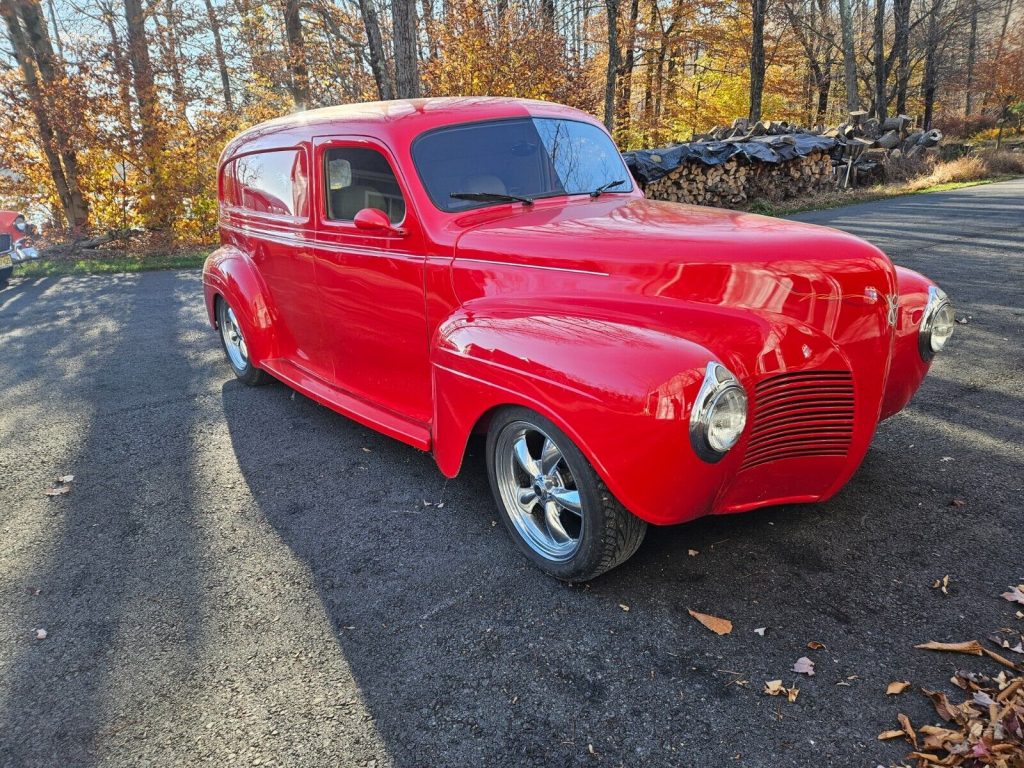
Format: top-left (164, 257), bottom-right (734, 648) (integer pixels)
top-left (485, 407), bottom-right (647, 582)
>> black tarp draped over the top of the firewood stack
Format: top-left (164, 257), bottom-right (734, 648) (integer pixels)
top-left (623, 133), bottom-right (837, 184)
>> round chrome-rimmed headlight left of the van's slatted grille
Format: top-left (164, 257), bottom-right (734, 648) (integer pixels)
top-left (690, 362), bottom-right (746, 463)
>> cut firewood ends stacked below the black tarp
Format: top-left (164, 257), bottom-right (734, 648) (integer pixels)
top-left (645, 150), bottom-right (835, 208)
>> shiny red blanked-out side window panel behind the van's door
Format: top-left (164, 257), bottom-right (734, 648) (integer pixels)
top-left (233, 150), bottom-right (309, 217)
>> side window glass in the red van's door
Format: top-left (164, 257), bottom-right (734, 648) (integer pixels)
top-left (324, 146), bottom-right (406, 224)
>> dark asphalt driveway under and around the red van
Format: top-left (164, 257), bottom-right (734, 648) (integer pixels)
top-left (0, 181), bottom-right (1024, 768)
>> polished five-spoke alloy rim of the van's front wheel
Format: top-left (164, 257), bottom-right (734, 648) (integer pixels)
top-left (494, 421), bottom-right (584, 562)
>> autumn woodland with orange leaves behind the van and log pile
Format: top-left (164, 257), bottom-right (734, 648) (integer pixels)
top-left (0, 0), bottom-right (1024, 242)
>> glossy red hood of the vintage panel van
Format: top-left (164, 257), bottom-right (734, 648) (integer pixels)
top-left (456, 196), bottom-right (896, 335)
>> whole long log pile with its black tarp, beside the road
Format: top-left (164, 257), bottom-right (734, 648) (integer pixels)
top-left (625, 112), bottom-right (942, 208)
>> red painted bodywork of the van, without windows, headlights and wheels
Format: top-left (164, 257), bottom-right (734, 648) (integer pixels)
top-left (204, 98), bottom-right (931, 523)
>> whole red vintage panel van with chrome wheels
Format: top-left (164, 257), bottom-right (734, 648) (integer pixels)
top-left (204, 98), bottom-right (954, 581)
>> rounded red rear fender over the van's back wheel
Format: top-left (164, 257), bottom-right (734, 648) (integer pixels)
top-left (203, 245), bottom-right (280, 367)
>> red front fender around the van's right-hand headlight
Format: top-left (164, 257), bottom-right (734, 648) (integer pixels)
top-left (880, 266), bottom-right (935, 419)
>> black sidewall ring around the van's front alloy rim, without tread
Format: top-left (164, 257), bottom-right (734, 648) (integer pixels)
top-left (486, 408), bottom-right (604, 582)
